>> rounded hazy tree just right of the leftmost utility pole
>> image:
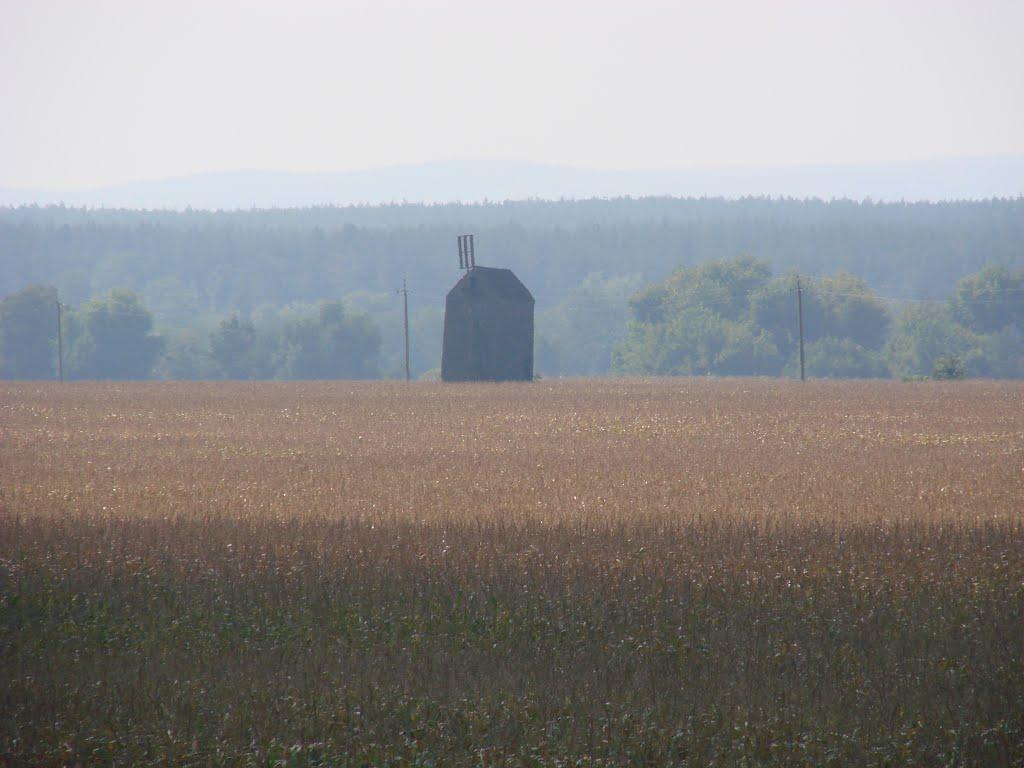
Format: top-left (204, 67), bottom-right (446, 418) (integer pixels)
top-left (70, 288), bottom-right (164, 379)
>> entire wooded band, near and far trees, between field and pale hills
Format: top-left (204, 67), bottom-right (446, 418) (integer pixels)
top-left (0, 198), bottom-right (1024, 379)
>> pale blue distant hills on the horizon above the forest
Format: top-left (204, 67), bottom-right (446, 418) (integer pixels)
top-left (0, 155), bottom-right (1024, 210)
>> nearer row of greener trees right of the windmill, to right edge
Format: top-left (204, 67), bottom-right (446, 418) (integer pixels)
top-left (612, 256), bottom-right (1024, 378)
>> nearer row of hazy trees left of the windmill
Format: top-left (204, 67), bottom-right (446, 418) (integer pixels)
top-left (0, 285), bottom-right (380, 380)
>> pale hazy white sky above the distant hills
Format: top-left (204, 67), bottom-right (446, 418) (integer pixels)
top-left (0, 0), bottom-right (1024, 186)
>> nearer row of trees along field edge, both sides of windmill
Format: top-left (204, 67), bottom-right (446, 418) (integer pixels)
top-left (0, 264), bottom-right (1024, 379)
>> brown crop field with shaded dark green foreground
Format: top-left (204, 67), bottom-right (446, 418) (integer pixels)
top-left (0, 379), bottom-right (1024, 766)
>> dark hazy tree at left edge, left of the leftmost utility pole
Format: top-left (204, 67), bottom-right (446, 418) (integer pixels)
top-left (0, 286), bottom-right (57, 379)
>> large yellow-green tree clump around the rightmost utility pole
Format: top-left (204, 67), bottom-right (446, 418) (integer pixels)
top-left (615, 257), bottom-right (901, 377)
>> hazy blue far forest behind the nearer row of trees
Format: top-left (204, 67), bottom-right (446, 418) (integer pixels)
top-left (0, 198), bottom-right (1024, 376)
